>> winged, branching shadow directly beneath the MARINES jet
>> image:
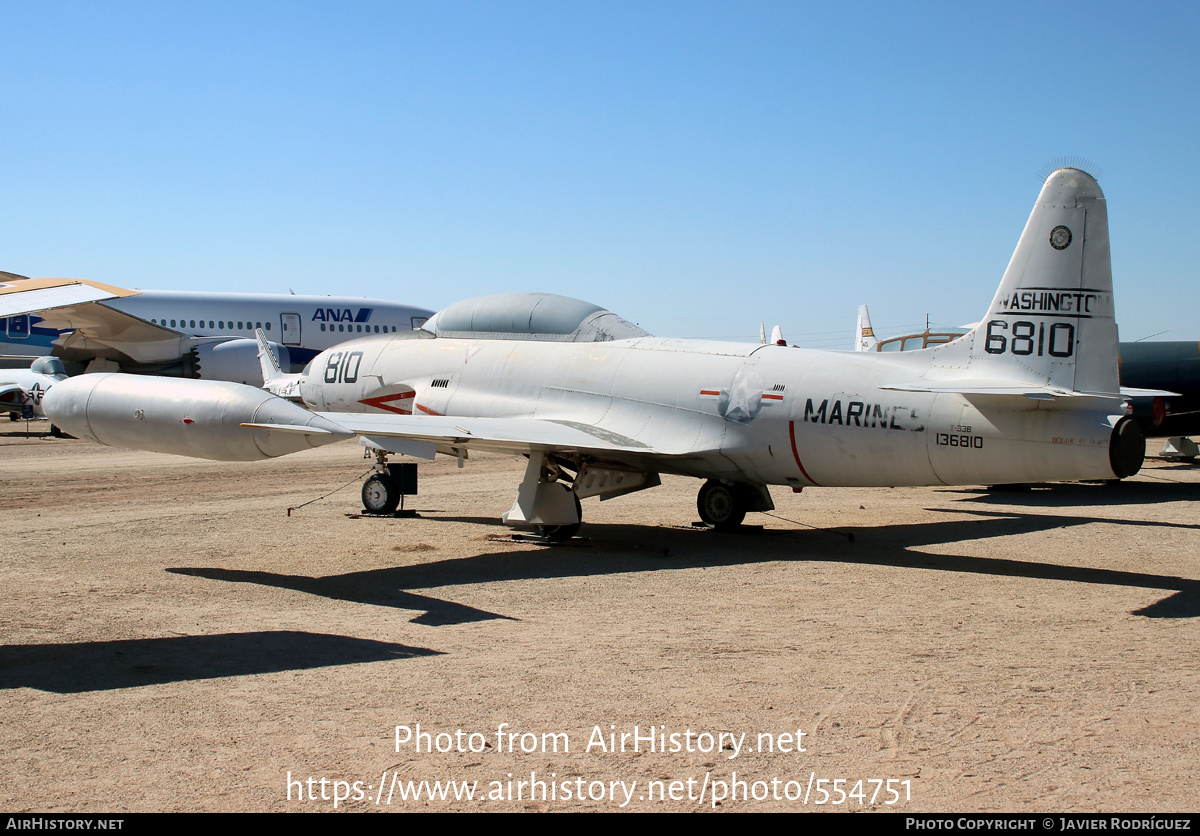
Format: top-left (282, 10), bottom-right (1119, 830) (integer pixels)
top-left (167, 509), bottom-right (1200, 626)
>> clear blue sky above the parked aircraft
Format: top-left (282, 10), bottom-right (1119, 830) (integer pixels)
top-left (0, 0), bottom-right (1200, 348)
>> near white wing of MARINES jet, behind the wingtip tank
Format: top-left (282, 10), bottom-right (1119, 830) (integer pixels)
top-left (317, 413), bottom-right (676, 461)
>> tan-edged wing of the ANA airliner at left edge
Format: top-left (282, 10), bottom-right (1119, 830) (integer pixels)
top-left (0, 278), bottom-right (186, 362)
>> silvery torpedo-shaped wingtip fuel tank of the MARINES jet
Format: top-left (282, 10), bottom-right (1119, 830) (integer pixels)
top-left (43, 374), bottom-right (354, 462)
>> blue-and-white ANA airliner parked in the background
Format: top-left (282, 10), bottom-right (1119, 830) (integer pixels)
top-left (0, 273), bottom-right (433, 385)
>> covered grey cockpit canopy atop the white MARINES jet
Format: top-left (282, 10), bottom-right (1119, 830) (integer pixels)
top-left (421, 293), bottom-right (650, 343)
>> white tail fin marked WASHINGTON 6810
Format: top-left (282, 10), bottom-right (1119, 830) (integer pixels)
top-left (926, 168), bottom-right (1120, 397)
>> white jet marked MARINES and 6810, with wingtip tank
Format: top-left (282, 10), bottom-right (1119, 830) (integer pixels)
top-left (46, 168), bottom-right (1145, 539)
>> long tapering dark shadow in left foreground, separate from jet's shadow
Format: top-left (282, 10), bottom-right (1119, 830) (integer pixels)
top-left (0, 630), bottom-right (442, 693)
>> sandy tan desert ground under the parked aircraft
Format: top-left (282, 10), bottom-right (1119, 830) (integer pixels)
top-left (0, 425), bottom-right (1200, 812)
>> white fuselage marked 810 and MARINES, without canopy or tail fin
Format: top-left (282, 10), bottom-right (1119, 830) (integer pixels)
top-left (301, 337), bottom-right (1121, 487)
